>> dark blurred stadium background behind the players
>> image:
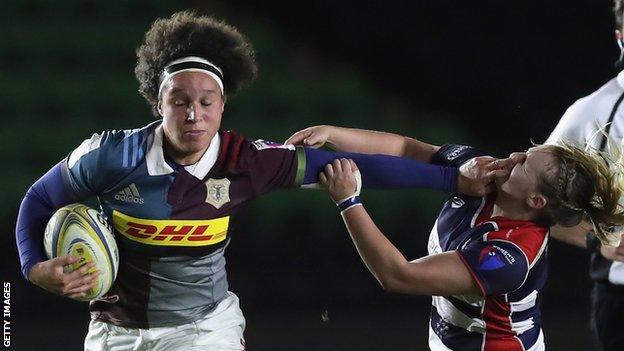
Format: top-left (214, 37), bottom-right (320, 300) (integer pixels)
top-left (0, 0), bottom-right (619, 350)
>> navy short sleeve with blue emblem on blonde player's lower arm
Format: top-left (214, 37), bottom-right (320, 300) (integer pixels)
top-left (457, 240), bottom-right (529, 296)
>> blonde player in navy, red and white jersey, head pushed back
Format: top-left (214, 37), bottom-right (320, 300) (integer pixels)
top-left (287, 126), bottom-right (624, 351)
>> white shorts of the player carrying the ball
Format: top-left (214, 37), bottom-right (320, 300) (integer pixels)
top-left (84, 292), bottom-right (245, 351)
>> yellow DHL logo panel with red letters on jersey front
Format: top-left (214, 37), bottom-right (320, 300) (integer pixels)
top-left (113, 211), bottom-right (230, 246)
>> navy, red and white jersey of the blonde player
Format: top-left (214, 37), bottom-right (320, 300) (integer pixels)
top-left (428, 145), bottom-right (548, 351)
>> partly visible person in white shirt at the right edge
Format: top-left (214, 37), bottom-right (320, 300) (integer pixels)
top-left (547, 0), bottom-right (624, 351)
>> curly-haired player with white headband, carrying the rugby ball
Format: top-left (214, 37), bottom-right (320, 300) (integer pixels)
top-left (16, 12), bottom-right (502, 350)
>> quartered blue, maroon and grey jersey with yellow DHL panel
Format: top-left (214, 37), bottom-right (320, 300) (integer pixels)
top-left (64, 122), bottom-right (305, 328)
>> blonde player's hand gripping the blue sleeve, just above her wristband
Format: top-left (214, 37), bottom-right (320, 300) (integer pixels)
top-left (319, 158), bottom-right (358, 202)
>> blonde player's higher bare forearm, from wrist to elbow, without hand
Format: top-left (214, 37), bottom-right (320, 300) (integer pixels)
top-left (326, 126), bottom-right (439, 162)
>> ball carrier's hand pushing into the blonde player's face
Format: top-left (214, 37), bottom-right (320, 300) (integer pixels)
top-left (457, 152), bottom-right (526, 196)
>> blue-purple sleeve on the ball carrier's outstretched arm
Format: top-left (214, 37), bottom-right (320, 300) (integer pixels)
top-left (300, 148), bottom-right (459, 192)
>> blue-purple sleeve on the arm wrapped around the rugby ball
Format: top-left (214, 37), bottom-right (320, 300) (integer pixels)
top-left (15, 160), bottom-right (79, 279)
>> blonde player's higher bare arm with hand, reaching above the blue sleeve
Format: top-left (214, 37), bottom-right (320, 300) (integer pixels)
top-left (285, 125), bottom-right (440, 162)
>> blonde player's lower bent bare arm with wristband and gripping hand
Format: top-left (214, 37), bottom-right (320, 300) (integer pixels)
top-left (321, 159), bottom-right (480, 295)
